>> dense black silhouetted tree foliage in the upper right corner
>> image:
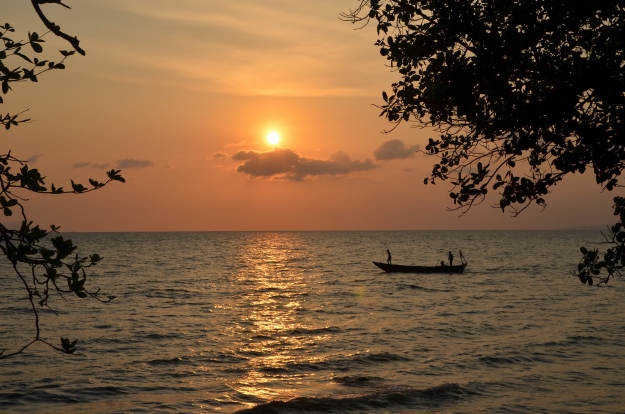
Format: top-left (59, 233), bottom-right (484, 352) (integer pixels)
top-left (342, 0), bottom-right (625, 284)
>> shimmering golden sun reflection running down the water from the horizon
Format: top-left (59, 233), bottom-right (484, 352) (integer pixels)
top-left (219, 233), bottom-right (329, 400)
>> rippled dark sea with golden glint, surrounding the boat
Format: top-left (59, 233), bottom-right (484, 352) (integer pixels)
top-left (0, 231), bottom-right (625, 413)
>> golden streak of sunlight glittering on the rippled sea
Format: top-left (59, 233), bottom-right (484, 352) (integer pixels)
top-left (229, 233), bottom-right (327, 400)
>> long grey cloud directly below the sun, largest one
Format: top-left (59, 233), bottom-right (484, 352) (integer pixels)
top-left (232, 148), bottom-right (376, 181)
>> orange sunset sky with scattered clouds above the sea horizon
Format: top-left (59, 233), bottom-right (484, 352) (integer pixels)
top-left (0, 0), bottom-right (615, 231)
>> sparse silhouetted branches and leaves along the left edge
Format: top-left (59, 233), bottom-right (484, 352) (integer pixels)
top-left (0, 0), bottom-right (124, 359)
